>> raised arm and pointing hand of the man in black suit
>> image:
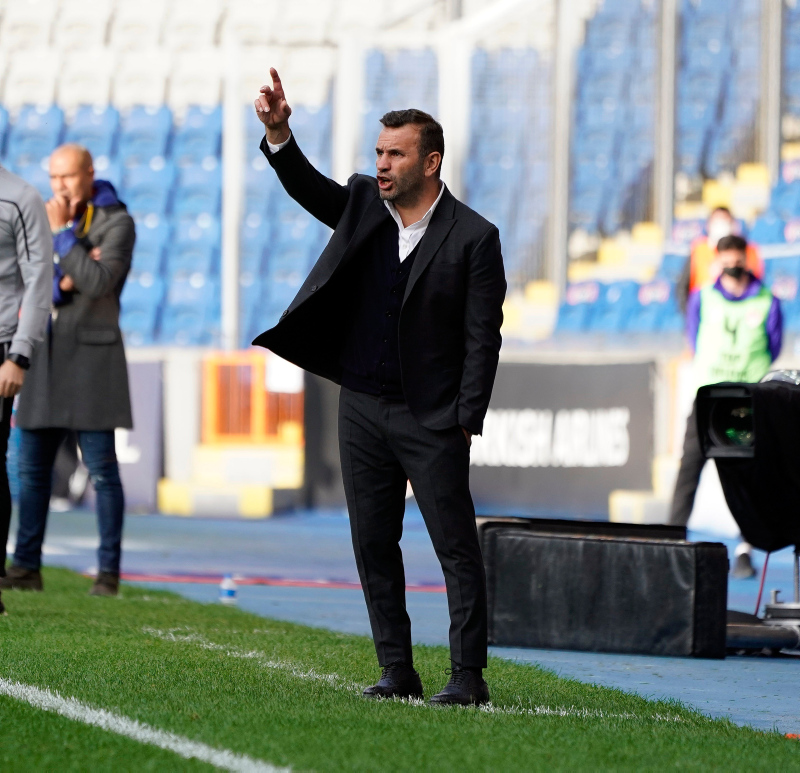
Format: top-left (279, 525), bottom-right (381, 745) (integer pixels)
top-left (254, 67), bottom-right (350, 228)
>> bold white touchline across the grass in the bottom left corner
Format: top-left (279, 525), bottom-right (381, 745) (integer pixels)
top-left (0, 677), bottom-right (291, 773)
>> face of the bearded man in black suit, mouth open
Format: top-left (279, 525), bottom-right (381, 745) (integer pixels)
top-left (375, 124), bottom-right (425, 206)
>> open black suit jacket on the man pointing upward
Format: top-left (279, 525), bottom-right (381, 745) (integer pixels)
top-left (253, 137), bottom-right (506, 434)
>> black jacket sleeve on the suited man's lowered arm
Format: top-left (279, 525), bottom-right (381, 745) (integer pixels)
top-left (458, 226), bottom-right (506, 435)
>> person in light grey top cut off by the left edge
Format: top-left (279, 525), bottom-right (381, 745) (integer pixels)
top-left (0, 167), bottom-right (53, 614)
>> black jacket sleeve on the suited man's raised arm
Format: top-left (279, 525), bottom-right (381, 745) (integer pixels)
top-left (261, 134), bottom-right (356, 228)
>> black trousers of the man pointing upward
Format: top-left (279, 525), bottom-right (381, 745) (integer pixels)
top-left (339, 388), bottom-right (487, 668)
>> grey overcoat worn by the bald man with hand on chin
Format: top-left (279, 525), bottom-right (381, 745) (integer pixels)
top-left (17, 205), bottom-right (136, 430)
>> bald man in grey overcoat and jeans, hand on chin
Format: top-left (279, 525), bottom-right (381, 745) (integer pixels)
top-left (0, 145), bottom-right (135, 596)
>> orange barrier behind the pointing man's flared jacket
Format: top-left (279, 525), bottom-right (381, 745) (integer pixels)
top-left (202, 352), bottom-right (303, 445)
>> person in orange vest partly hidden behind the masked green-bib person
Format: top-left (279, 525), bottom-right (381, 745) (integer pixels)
top-left (678, 207), bottom-right (764, 309)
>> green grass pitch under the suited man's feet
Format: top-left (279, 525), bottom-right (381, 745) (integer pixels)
top-left (0, 569), bottom-right (800, 771)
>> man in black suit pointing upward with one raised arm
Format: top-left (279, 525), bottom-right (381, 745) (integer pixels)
top-left (253, 69), bottom-right (506, 704)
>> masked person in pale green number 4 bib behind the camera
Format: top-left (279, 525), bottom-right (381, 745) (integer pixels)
top-left (670, 235), bottom-right (783, 577)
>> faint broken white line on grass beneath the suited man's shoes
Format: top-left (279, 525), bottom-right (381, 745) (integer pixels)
top-left (142, 627), bottom-right (686, 722)
